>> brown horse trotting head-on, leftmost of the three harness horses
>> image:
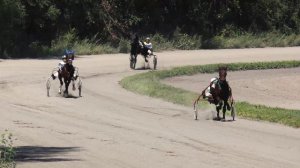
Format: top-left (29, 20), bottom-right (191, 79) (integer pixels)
top-left (58, 62), bottom-right (75, 97)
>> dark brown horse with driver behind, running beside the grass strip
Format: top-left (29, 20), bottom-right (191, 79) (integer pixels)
top-left (194, 67), bottom-right (235, 120)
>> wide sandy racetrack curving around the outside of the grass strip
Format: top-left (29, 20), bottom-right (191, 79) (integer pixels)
top-left (0, 47), bottom-right (300, 168)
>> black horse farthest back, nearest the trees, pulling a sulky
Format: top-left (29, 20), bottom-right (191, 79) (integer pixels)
top-left (130, 35), bottom-right (149, 69)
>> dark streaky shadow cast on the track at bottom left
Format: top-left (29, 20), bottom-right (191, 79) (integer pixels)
top-left (15, 146), bottom-right (80, 162)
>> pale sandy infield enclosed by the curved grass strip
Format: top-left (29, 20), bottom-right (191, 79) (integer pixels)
top-left (163, 68), bottom-right (300, 109)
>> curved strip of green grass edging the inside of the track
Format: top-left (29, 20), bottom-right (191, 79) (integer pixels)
top-left (120, 61), bottom-right (300, 128)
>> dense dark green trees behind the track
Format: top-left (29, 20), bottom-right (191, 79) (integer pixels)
top-left (0, 0), bottom-right (300, 57)
